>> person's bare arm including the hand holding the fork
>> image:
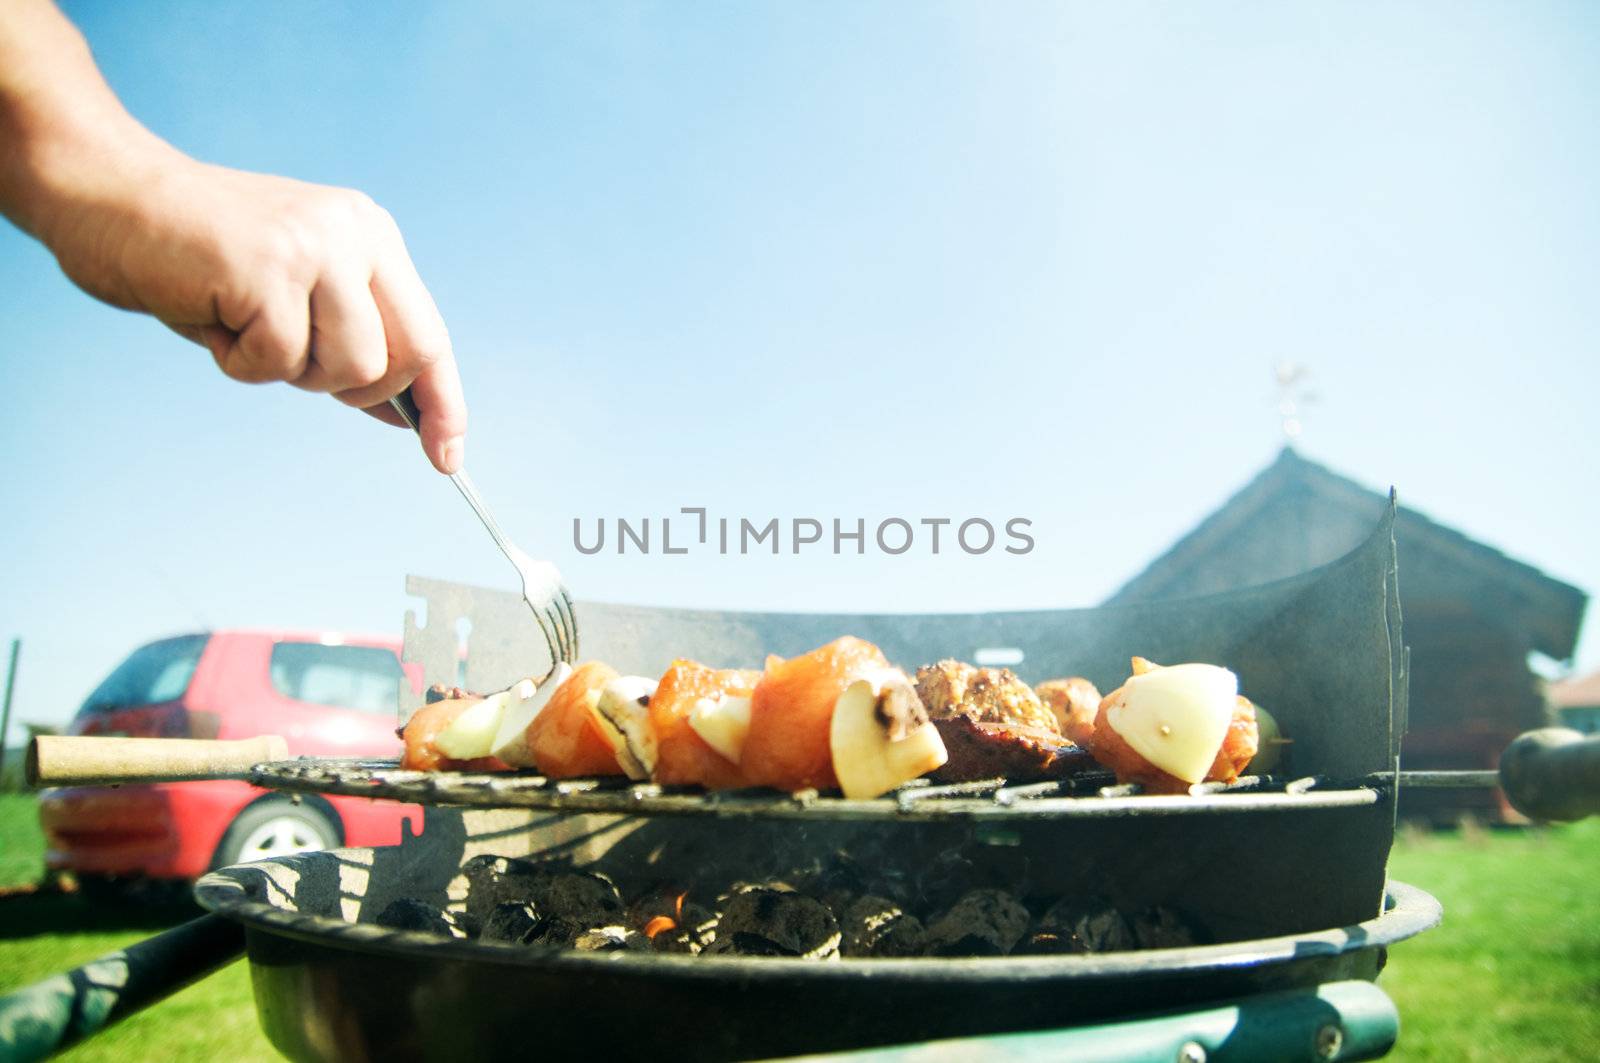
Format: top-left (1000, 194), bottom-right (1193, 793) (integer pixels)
top-left (0, 0), bottom-right (467, 472)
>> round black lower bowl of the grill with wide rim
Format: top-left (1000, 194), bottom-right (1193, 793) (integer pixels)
top-left (195, 848), bottom-right (1440, 1060)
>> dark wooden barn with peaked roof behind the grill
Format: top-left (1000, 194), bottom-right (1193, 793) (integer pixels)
top-left (1107, 448), bottom-right (1587, 823)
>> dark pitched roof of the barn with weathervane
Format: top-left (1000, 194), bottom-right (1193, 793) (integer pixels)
top-left (1107, 447), bottom-right (1587, 660)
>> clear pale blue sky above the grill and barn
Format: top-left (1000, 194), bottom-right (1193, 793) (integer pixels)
top-left (0, 3), bottom-right (1600, 739)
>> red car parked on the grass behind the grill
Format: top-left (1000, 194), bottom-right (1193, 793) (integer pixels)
top-left (38, 631), bottom-right (422, 879)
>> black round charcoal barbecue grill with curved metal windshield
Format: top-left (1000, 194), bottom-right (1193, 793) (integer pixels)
top-left (0, 507), bottom-right (1592, 1061)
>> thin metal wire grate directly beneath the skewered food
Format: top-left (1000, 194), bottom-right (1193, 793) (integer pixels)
top-left (245, 757), bottom-right (1382, 821)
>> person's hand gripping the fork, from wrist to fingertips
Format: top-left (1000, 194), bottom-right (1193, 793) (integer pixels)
top-left (38, 138), bottom-right (467, 472)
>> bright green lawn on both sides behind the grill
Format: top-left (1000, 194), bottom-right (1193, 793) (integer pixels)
top-left (0, 794), bottom-right (1600, 1063)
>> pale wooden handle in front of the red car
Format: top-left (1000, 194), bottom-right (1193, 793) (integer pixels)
top-left (27, 735), bottom-right (290, 786)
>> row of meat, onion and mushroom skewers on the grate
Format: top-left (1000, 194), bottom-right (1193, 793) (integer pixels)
top-left (403, 637), bottom-right (1258, 799)
